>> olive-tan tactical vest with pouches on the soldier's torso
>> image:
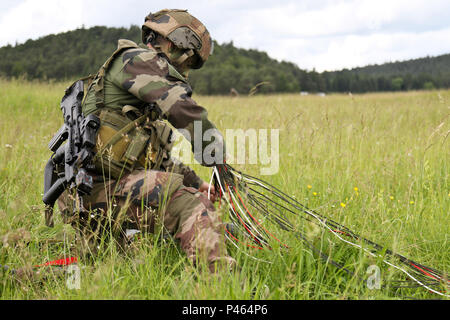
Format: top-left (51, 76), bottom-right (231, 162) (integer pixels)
top-left (83, 39), bottom-right (173, 179)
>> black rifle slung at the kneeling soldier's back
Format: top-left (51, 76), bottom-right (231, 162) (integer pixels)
top-left (42, 80), bottom-right (100, 227)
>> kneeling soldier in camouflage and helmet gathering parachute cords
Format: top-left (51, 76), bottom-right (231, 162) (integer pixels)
top-left (58, 10), bottom-right (235, 271)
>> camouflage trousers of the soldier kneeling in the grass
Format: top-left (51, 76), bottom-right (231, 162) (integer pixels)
top-left (58, 169), bottom-right (235, 272)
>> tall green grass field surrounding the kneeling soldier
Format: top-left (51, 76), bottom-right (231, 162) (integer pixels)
top-left (0, 80), bottom-right (450, 299)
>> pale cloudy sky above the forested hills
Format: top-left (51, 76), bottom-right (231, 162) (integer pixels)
top-left (0, 0), bottom-right (450, 72)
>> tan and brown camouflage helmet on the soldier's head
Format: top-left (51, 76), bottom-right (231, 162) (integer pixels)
top-left (142, 9), bottom-right (213, 69)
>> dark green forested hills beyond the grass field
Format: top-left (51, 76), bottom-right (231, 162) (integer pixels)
top-left (0, 26), bottom-right (450, 94)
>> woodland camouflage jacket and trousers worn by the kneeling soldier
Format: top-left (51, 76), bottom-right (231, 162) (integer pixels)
top-left (58, 40), bottom-right (235, 271)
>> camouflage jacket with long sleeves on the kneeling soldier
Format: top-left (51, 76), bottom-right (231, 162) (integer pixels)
top-left (83, 39), bottom-right (220, 187)
